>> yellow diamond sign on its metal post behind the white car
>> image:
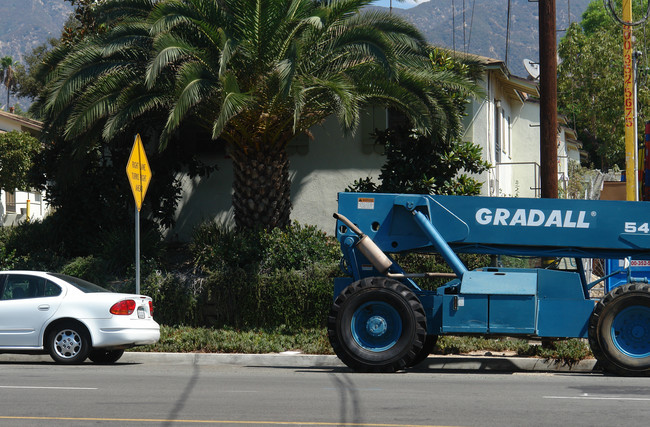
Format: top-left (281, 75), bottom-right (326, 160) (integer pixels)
top-left (126, 134), bottom-right (151, 294)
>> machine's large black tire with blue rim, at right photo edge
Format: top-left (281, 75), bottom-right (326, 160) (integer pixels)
top-left (589, 283), bottom-right (650, 376)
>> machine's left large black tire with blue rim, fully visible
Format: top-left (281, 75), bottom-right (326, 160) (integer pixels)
top-left (327, 277), bottom-right (427, 372)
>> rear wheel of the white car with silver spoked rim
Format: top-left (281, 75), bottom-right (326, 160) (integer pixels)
top-left (47, 322), bottom-right (91, 365)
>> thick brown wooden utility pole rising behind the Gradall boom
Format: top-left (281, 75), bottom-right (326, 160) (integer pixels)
top-left (538, 0), bottom-right (558, 199)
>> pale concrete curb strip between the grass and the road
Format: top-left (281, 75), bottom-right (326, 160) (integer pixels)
top-left (0, 352), bottom-right (597, 372)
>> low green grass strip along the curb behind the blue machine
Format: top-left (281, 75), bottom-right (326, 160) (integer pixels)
top-left (133, 326), bottom-right (593, 363)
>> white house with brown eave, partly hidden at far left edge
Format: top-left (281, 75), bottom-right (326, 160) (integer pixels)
top-left (0, 110), bottom-right (48, 226)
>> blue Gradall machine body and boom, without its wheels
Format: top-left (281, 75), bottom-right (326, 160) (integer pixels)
top-left (335, 193), bottom-right (650, 338)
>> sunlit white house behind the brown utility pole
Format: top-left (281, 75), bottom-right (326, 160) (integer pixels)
top-left (463, 57), bottom-right (585, 197)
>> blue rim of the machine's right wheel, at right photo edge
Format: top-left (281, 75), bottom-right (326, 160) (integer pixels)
top-left (611, 305), bottom-right (650, 359)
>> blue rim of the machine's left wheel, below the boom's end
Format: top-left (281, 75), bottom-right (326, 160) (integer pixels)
top-left (350, 301), bottom-right (402, 352)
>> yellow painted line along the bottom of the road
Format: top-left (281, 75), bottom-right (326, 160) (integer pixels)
top-left (0, 415), bottom-right (459, 427)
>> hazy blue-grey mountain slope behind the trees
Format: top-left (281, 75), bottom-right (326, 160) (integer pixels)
top-left (0, 0), bottom-right (600, 97)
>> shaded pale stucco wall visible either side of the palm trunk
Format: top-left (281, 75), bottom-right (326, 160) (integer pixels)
top-left (168, 113), bottom-right (385, 241)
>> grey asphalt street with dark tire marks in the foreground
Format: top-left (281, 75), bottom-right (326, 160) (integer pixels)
top-left (0, 359), bottom-right (650, 427)
